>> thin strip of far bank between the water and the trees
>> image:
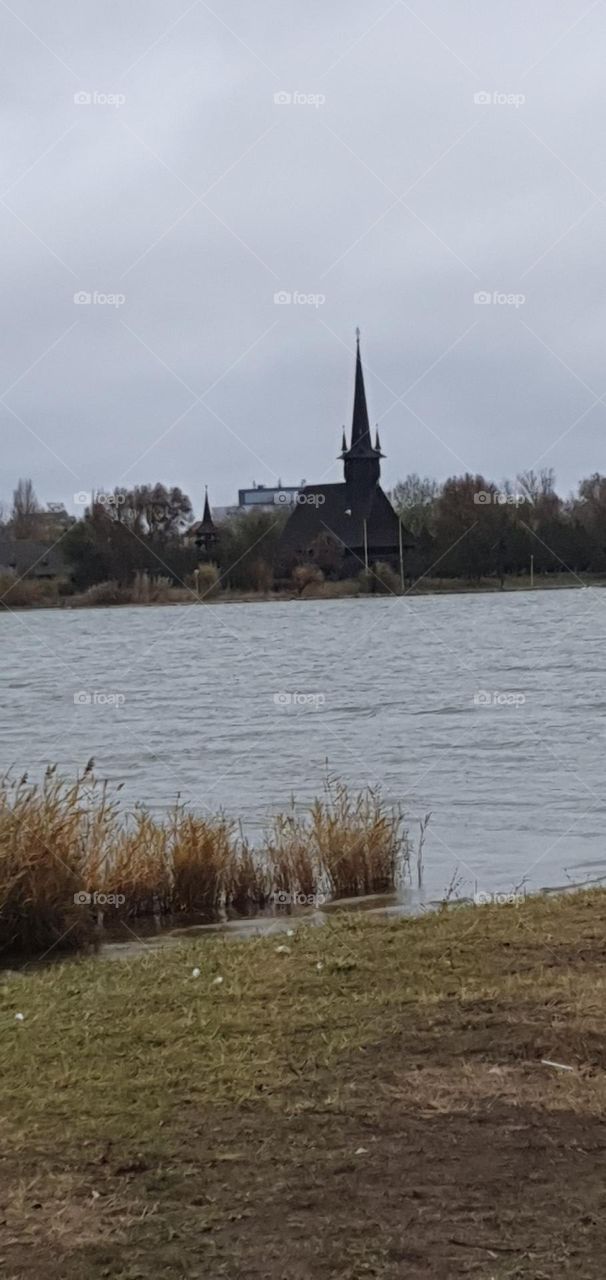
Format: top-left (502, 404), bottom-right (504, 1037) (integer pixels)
top-left (0, 571), bottom-right (606, 612)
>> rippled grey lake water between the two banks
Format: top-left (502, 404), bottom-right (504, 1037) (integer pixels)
top-left (0, 589), bottom-right (606, 895)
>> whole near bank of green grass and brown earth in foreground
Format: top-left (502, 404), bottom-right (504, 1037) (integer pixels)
top-left (0, 891), bottom-right (606, 1280)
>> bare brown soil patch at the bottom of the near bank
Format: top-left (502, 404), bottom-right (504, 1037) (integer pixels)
top-left (0, 1001), bottom-right (606, 1280)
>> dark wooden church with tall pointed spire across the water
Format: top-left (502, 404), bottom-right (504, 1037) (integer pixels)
top-left (275, 330), bottom-right (414, 577)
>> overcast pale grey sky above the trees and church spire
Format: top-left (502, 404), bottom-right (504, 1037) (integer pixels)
top-left (0, 0), bottom-right (606, 512)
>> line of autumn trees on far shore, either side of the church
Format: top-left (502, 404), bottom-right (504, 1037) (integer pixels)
top-left (1, 468), bottom-right (606, 591)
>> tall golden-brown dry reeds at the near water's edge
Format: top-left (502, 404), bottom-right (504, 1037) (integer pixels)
top-left (0, 760), bottom-right (409, 955)
